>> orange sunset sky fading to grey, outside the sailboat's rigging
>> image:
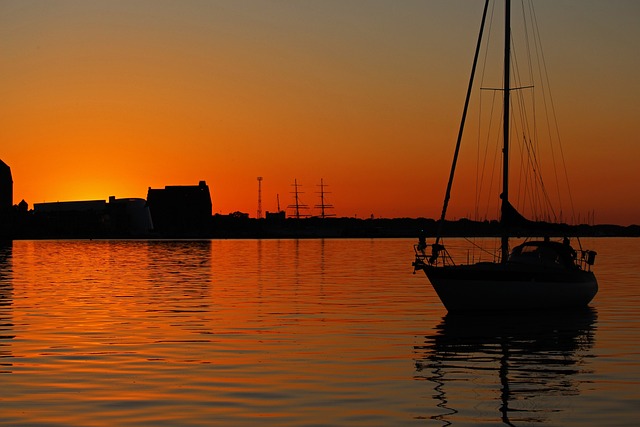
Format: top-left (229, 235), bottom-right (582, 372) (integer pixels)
top-left (0, 0), bottom-right (640, 224)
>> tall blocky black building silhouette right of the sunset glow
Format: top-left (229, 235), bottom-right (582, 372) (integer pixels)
top-left (147, 181), bottom-right (212, 237)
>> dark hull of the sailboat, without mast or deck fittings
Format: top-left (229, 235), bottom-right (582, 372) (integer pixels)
top-left (423, 263), bottom-right (598, 311)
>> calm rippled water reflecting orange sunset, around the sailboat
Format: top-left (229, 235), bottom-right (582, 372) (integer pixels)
top-left (0, 239), bottom-right (640, 426)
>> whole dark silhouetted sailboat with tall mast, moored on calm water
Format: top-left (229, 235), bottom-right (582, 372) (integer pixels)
top-left (413, 0), bottom-right (598, 312)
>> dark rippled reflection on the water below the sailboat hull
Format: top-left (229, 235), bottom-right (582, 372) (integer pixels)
top-left (416, 308), bottom-right (597, 425)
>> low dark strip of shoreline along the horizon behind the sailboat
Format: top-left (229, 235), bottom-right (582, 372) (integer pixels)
top-left (0, 215), bottom-right (640, 240)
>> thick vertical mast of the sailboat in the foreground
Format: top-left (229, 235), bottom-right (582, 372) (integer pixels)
top-left (500, 0), bottom-right (511, 263)
